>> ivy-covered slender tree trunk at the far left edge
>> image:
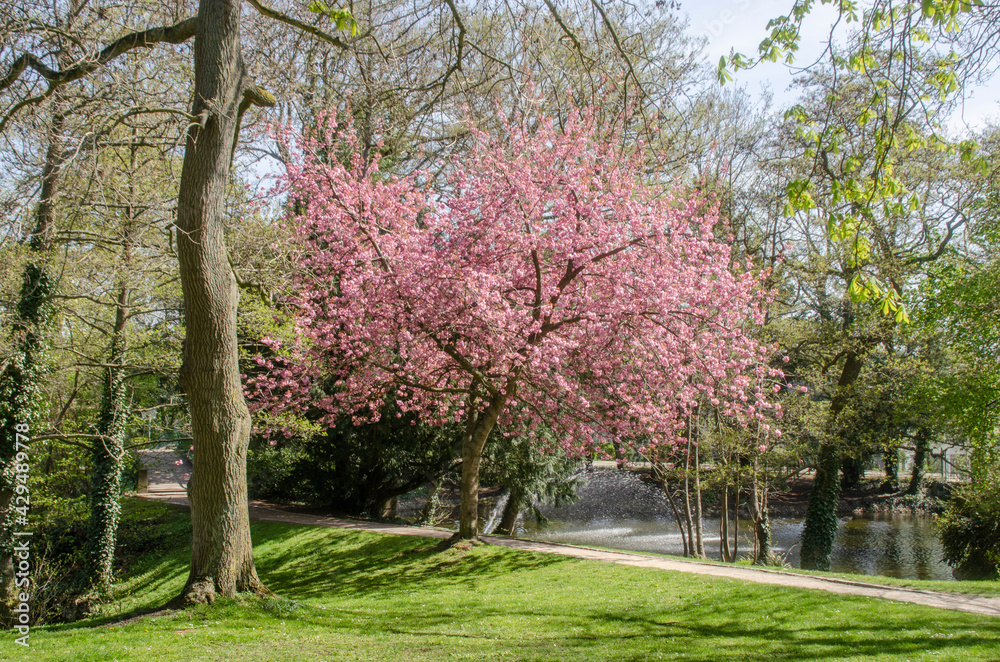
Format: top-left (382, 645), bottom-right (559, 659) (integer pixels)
top-left (0, 109), bottom-right (65, 627)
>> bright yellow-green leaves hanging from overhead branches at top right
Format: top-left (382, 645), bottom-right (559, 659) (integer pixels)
top-left (719, 0), bottom-right (988, 324)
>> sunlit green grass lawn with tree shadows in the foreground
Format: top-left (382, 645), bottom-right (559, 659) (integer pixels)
top-left (13, 506), bottom-right (1000, 662)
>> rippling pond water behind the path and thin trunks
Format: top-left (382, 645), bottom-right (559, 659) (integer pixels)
top-left (508, 471), bottom-right (952, 580)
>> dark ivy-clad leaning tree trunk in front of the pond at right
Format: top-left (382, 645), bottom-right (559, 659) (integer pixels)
top-left (801, 350), bottom-right (862, 570)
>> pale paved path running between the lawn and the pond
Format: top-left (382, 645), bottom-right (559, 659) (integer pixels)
top-left (140, 490), bottom-right (1000, 617)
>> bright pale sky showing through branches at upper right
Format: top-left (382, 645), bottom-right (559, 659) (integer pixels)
top-left (681, 0), bottom-right (1000, 132)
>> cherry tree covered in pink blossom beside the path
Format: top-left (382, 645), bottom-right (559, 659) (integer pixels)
top-left (250, 107), bottom-right (781, 539)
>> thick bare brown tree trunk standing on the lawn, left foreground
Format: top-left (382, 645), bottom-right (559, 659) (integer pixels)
top-left (177, 0), bottom-right (266, 602)
